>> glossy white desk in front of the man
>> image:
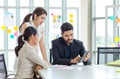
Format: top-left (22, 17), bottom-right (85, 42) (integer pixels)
top-left (39, 65), bottom-right (120, 79)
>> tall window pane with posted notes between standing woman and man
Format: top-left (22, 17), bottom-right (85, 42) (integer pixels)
top-left (49, 9), bottom-right (62, 48)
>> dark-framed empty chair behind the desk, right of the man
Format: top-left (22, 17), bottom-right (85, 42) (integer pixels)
top-left (97, 47), bottom-right (120, 64)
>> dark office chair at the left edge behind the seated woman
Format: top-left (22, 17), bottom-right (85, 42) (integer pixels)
top-left (0, 54), bottom-right (15, 79)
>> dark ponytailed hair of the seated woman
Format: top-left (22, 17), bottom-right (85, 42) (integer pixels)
top-left (15, 26), bottom-right (37, 57)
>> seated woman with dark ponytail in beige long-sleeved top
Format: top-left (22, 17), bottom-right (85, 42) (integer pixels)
top-left (15, 26), bottom-right (48, 78)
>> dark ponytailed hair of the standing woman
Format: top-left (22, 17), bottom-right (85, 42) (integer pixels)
top-left (19, 7), bottom-right (47, 31)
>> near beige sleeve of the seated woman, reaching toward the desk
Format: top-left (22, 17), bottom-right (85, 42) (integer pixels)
top-left (27, 49), bottom-right (48, 69)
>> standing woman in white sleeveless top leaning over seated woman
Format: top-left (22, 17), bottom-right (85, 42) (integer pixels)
top-left (20, 7), bottom-right (48, 62)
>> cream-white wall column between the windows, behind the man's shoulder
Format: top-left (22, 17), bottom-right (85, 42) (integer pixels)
top-left (79, 0), bottom-right (92, 50)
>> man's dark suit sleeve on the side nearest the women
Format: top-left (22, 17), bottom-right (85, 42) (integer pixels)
top-left (52, 42), bottom-right (71, 65)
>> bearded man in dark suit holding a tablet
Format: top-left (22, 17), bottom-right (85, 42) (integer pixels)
top-left (52, 22), bottom-right (90, 65)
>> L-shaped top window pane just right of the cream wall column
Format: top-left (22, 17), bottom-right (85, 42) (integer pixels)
top-left (95, 0), bottom-right (113, 17)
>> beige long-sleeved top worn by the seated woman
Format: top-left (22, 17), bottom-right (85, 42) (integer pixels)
top-left (15, 42), bottom-right (48, 78)
